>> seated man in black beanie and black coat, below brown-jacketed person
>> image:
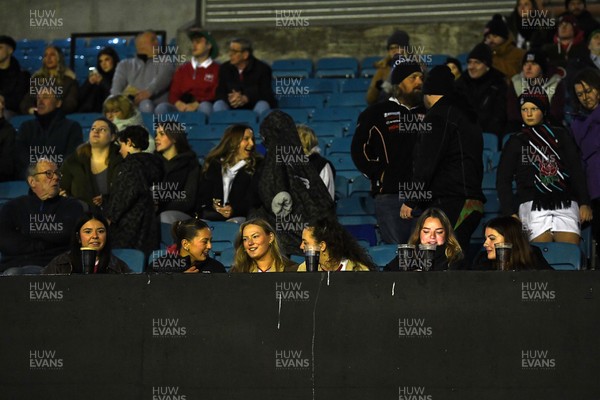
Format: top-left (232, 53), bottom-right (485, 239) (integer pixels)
top-left (456, 43), bottom-right (508, 137)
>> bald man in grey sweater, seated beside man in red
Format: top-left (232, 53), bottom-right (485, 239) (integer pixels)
top-left (110, 31), bottom-right (174, 113)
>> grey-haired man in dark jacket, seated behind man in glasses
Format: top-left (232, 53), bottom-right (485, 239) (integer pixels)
top-left (16, 86), bottom-right (83, 176)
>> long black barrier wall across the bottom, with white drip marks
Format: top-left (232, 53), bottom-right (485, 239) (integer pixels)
top-left (0, 271), bottom-right (600, 400)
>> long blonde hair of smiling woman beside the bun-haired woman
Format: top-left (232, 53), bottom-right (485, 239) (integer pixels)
top-left (231, 218), bottom-right (288, 272)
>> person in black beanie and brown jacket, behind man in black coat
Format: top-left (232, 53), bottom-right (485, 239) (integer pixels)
top-left (483, 14), bottom-right (525, 79)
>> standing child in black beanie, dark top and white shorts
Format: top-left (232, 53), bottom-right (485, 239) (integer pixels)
top-left (496, 91), bottom-right (592, 245)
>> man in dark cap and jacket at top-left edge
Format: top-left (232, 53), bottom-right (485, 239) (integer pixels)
top-left (0, 35), bottom-right (29, 119)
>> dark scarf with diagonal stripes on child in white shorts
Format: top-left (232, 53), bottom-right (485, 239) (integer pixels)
top-left (522, 123), bottom-right (571, 210)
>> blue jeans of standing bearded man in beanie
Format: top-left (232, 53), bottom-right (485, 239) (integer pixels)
top-left (375, 194), bottom-right (416, 244)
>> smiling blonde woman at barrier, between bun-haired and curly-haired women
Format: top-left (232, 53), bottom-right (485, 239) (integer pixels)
top-left (231, 218), bottom-right (298, 272)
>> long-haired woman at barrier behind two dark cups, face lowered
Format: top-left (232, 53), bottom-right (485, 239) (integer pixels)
top-left (384, 207), bottom-right (465, 271)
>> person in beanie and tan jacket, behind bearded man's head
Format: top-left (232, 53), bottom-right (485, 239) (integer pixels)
top-left (367, 30), bottom-right (410, 104)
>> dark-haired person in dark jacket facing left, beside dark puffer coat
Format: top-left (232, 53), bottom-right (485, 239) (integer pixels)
top-left (153, 122), bottom-right (200, 215)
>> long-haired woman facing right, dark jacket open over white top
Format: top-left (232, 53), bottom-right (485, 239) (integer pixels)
top-left (199, 124), bottom-right (262, 222)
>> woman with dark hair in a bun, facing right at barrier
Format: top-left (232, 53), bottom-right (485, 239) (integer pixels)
top-left (152, 218), bottom-right (227, 273)
